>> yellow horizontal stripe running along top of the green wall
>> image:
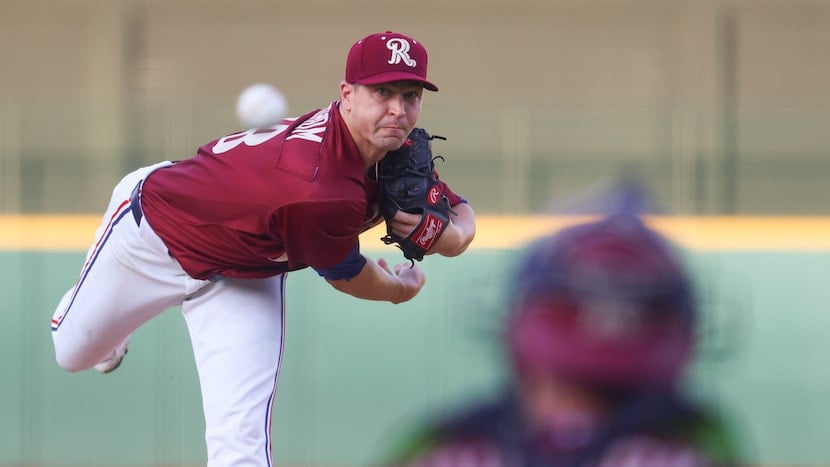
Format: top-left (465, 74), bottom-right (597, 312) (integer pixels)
top-left (0, 215), bottom-right (830, 251)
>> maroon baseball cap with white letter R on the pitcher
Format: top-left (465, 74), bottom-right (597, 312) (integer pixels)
top-left (346, 31), bottom-right (438, 91)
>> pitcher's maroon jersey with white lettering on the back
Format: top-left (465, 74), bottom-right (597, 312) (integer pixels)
top-left (141, 102), bottom-right (462, 279)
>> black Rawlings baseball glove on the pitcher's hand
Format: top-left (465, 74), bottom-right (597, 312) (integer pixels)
top-left (373, 128), bottom-right (455, 265)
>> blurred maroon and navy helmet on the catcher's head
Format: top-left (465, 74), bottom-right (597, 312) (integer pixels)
top-left (505, 215), bottom-right (696, 390)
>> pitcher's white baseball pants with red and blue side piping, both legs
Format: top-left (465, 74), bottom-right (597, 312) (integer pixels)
top-left (52, 162), bottom-right (285, 467)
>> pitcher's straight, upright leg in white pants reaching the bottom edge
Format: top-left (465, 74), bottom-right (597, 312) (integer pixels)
top-left (182, 275), bottom-right (285, 467)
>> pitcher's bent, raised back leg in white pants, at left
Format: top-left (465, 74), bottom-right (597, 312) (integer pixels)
top-left (52, 161), bottom-right (186, 371)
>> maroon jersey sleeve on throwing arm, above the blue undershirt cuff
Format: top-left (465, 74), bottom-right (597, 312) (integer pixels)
top-left (276, 200), bottom-right (365, 269)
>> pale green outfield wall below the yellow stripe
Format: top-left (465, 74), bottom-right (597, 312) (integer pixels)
top-left (0, 218), bottom-right (830, 466)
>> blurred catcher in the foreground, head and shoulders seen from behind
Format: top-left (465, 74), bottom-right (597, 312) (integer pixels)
top-left (386, 207), bottom-right (737, 467)
